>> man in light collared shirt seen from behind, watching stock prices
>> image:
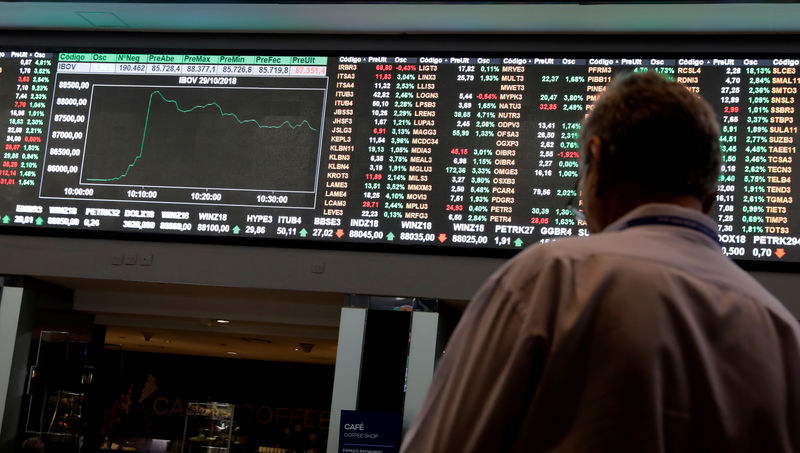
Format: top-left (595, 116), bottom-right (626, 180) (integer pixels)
top-left (402, 73), bottom-right (800, 453)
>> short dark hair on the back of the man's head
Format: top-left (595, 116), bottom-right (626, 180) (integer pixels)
top-left (579, 72), bottom-right (721, 201)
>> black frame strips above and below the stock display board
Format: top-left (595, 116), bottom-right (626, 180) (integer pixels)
top-left (0, 30), bottom-right (800, 273)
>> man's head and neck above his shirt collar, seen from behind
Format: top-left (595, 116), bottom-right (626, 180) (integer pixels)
top-left (578, 72), bottom-right (721, 232)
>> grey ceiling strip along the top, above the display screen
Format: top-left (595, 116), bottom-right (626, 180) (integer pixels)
top-left (0, 0), bottom-right (800, 34)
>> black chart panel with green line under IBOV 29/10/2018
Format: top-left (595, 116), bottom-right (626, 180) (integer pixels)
top-left (81, 85), bottom-right (324, 192)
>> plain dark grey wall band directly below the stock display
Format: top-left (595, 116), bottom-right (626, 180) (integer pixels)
top-left (0, 231), bottom-right (800, 317)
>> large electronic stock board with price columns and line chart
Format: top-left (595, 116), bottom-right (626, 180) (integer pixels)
top-left (0, 51), bottom-right (800, 261)
